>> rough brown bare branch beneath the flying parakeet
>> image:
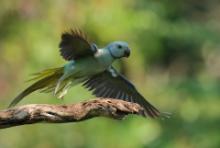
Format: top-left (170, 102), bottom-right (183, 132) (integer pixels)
top-left (0, 98), bottom-right (148, 129)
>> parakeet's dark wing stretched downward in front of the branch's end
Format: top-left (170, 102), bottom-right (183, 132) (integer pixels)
top-left (83, 67), bottom-right (161, 118)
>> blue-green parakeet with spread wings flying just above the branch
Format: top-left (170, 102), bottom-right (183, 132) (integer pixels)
top-left (9, 29), bottom-right (162, 118)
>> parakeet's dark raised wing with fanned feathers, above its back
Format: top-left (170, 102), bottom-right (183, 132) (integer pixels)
top-left (59, 30), bottom-right (96, 61)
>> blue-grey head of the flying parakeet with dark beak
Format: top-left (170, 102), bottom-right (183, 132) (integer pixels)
top-left (106, 41), bottom-right (131, 59)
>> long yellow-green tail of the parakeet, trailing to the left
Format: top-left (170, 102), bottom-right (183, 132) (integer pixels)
top-left (9, 67), bottom-right (63, 107)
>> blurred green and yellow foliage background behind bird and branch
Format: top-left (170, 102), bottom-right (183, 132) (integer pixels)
top-left (0, 0), bottom-right (220, 148)
